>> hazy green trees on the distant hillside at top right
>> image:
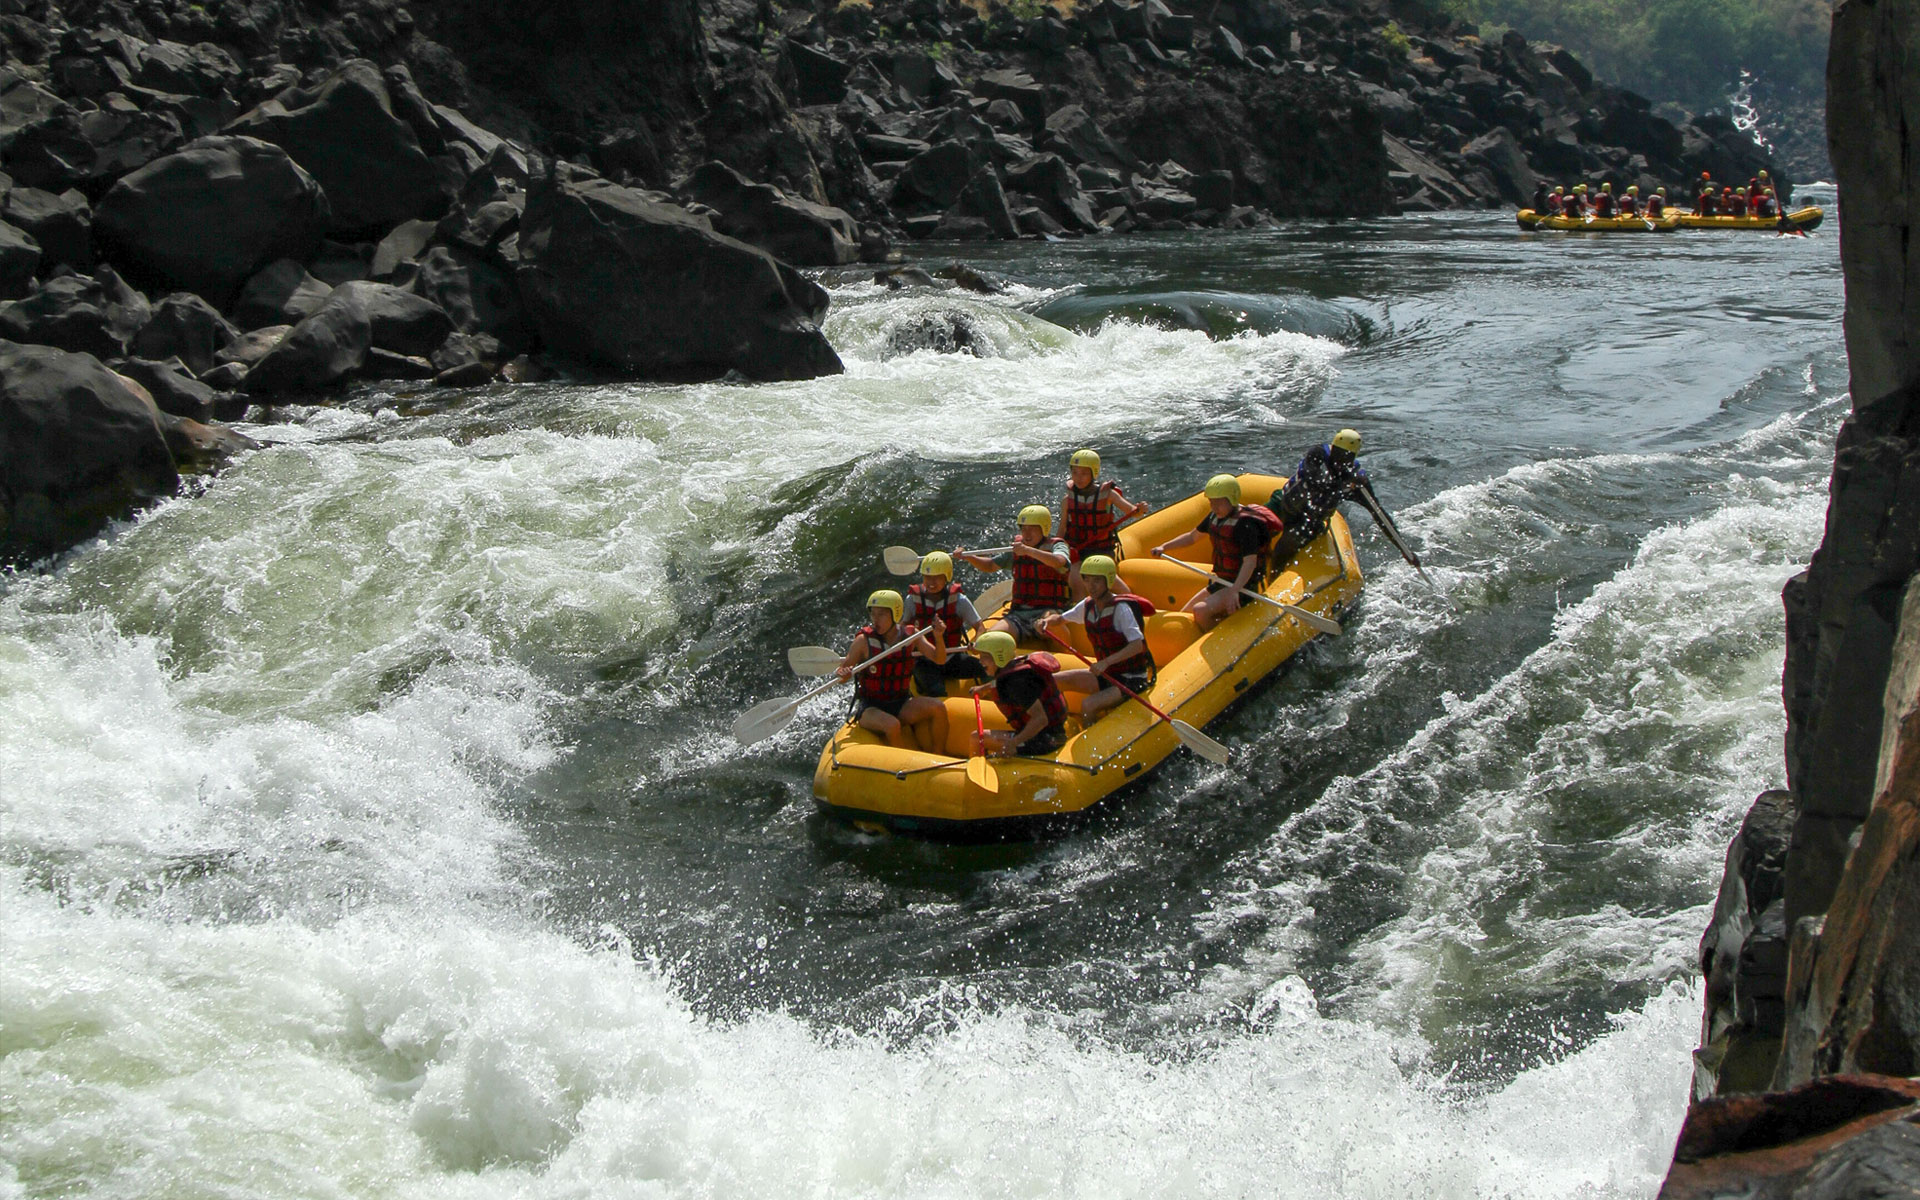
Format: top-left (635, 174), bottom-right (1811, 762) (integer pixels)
top-left (1442, 0), bottom-right (1832, 109)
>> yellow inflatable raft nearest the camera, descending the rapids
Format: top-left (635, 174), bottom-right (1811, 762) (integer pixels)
top-left (814, 474), bottom-right (1361, 839)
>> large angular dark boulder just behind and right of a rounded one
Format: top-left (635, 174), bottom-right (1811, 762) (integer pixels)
top-left (228, 60), bottom-right (449, 234)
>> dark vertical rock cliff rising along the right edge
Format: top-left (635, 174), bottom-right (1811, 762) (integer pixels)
top-left (1661, 0), bottom-right (1920, 1200)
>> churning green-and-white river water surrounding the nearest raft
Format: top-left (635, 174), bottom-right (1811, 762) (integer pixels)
top-left (0, 196), bottom-right (1847, 1198)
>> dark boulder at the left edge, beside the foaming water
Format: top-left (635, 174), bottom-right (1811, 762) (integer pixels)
top-left (0, 342), bottom-right (180, 563)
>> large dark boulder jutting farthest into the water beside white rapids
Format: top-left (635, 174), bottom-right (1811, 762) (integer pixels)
top-left (518, 171), bottom-right (843, 380)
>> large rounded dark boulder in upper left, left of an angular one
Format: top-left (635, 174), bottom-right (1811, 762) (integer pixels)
top-left (96, 136), bottom-right (326, 305)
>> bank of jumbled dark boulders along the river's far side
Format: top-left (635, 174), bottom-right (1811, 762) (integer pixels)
top-left (0, 0), bottom-right (1784, 559)
